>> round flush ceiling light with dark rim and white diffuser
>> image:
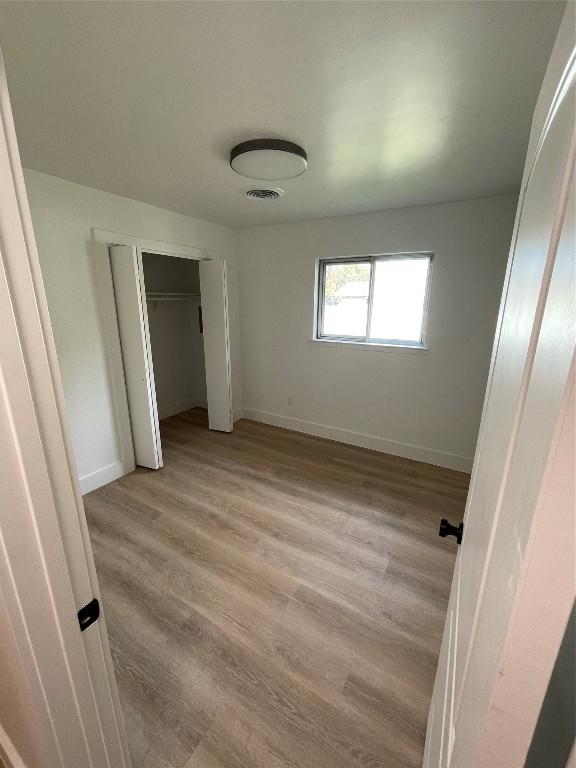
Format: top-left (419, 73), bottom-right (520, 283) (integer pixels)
top-left (230, 139), bottom-right (308, 181)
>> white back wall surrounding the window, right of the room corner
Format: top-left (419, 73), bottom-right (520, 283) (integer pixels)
top-left (239, 196), bottom-right (517, 470)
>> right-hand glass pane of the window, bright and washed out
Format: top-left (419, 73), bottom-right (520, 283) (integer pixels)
top-left (369, 259), bottom-right (430, 341)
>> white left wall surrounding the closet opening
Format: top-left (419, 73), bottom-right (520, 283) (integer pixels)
top-left (25, 171), bottom-right (242, 491)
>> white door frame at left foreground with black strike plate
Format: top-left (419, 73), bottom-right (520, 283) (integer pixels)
top-left (0, 46), bottom-right (129, 768)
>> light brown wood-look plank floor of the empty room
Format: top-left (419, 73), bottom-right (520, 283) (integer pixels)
top-left (85, 410), bottom-right (468, 768)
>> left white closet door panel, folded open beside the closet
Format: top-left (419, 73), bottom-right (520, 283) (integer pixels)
top-left (110, 245), bottom-right (162, 469)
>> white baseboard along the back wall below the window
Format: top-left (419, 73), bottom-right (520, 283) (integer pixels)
top-left (243, 408), bottom-right (473, 472)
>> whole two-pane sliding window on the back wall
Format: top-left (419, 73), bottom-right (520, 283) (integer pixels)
top-left (316, 253), bottom-right (432, 347)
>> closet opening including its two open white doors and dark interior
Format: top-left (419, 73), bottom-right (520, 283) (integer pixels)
top-left (109, 245), bottom-right (233, 469)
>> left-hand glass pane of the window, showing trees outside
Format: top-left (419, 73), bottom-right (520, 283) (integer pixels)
top-left (322, 262), bottom-right (371, 338)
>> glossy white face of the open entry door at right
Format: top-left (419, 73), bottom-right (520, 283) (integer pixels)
top-left (424, 21), bottom-right (576, 768)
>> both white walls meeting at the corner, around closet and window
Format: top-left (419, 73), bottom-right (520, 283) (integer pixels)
top-left (25, 171), bottom-right (516, 490)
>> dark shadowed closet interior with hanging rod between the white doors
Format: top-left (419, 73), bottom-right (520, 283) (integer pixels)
top-left (142, 253), bottom-right (207, 419)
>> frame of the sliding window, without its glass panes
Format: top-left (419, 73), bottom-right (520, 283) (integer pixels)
top-left (313, 251), bottom-right (434, 349)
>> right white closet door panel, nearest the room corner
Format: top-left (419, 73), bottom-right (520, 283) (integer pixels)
top-left (200, 259), bottom-right (233, 432)
